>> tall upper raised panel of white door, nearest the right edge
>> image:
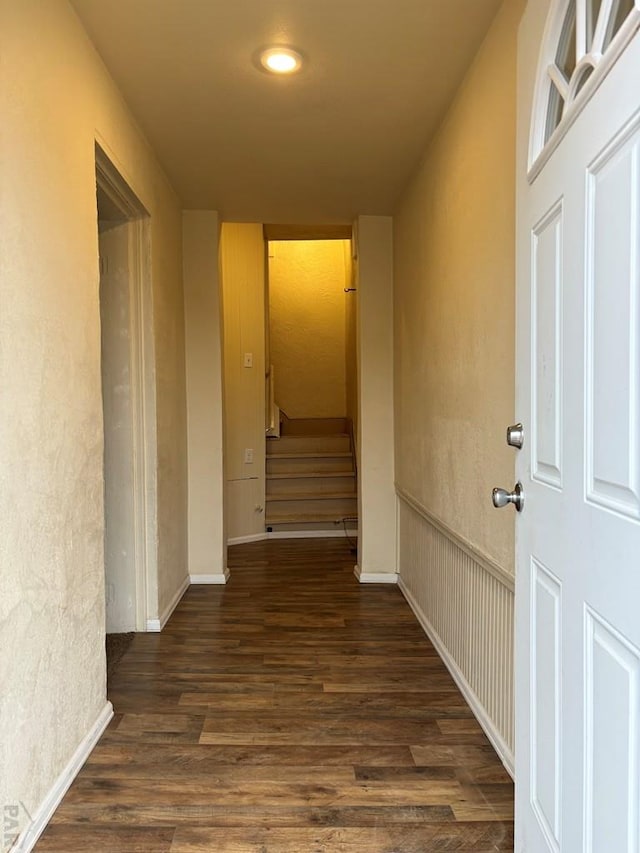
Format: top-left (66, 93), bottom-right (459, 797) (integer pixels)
top-left (586, 129), bottom-right (640, 518)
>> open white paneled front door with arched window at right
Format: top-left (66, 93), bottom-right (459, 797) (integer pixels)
top-left (516, 0), bottom-right (640, 853)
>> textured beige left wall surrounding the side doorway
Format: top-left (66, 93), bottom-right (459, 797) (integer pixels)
top-left (0, 0), bottom-right (186, 840)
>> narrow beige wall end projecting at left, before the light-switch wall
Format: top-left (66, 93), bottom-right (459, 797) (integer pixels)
top-left (182, 210), bottom-right (227, 580)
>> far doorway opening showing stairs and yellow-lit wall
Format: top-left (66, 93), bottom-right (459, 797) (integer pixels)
top-left (265, 233), bottom-right (358, 549)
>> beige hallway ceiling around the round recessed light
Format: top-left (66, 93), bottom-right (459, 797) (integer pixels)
top-left (72, 0), bottom-right (501, 223)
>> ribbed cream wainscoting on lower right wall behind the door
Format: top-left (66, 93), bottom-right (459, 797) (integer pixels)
top-left (398, 491), bottom-right (514, 776)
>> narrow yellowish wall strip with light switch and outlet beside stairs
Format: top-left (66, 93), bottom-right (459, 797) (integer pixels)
top-left (220, 222), bottom-right (266, 541)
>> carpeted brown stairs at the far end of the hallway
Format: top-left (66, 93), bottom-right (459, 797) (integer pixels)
top-left (265, 418), bottom-right (358, 534)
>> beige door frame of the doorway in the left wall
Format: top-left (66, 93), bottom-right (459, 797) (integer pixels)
top-left (95, 142), bottom-right (158, 631)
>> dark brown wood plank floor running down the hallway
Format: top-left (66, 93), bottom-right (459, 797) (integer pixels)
top-left (36, 539), bottom-right (513, 853)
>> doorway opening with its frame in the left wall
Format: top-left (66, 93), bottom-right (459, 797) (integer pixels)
top-left (96, 145), bottom-right (156, 670)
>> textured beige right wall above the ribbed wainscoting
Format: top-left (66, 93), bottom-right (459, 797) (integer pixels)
top-left (394, 0), bottom-right (524, 572)
